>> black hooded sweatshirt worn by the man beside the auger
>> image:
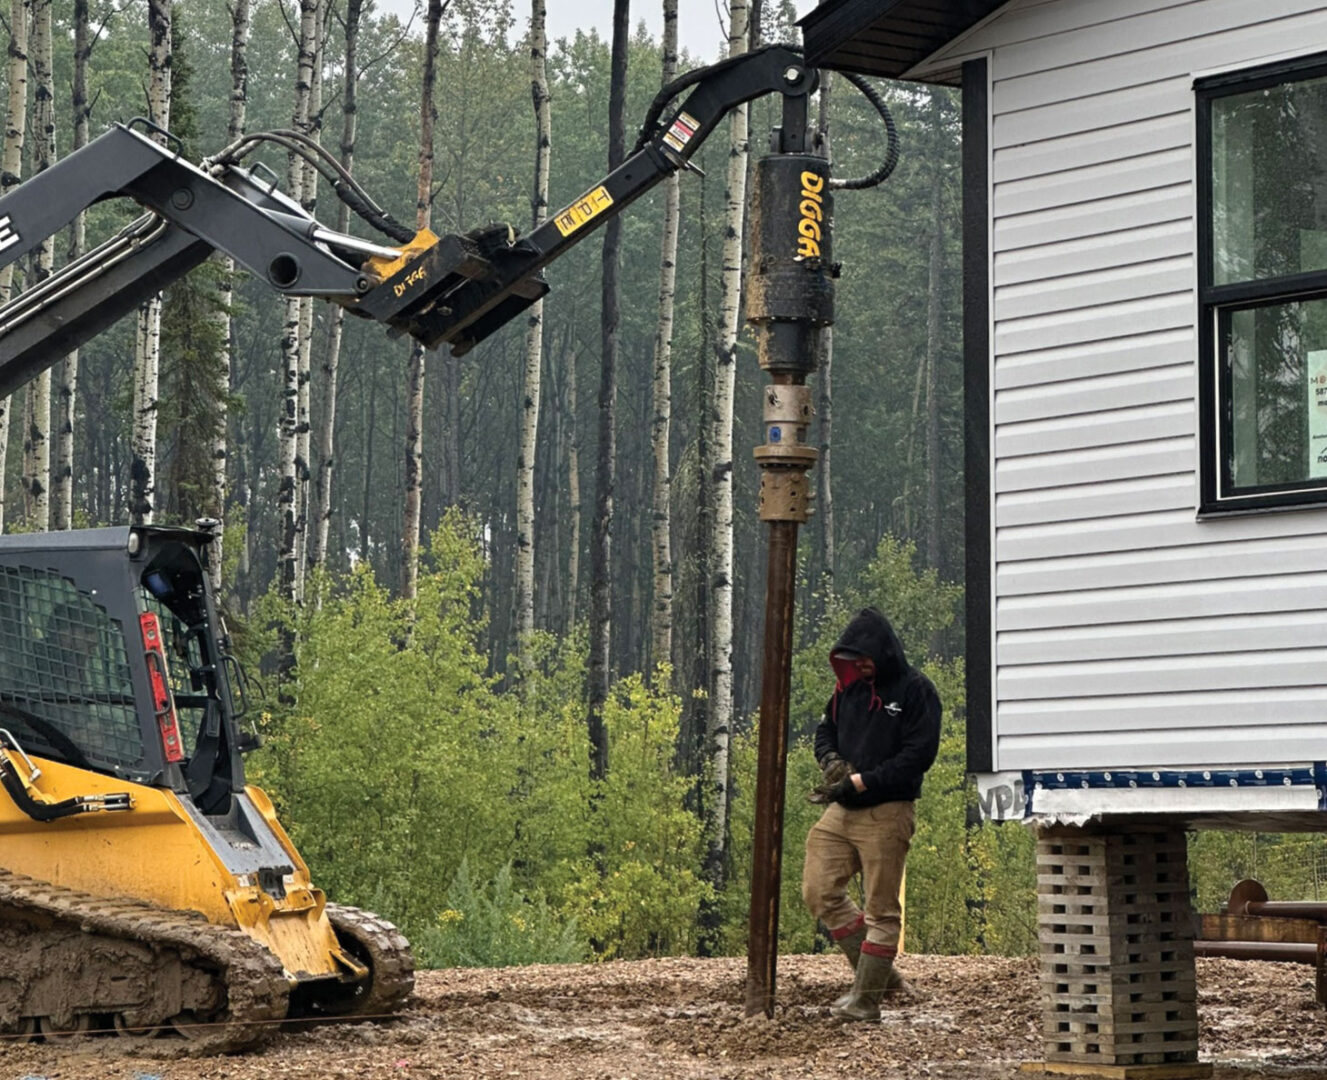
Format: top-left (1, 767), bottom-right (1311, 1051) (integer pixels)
top-left (816, 608), bottom-right (940, 808)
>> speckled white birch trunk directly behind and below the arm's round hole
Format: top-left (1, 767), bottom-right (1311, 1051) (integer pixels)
top-left (277, 0), bottom-right (318, 602)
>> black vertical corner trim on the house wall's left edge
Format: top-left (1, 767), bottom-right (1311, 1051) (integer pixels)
top-left (962, 57), bottom-right (995, 772)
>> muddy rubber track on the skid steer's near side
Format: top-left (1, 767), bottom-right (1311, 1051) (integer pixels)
top-left (0, 870), bottom-right (289, 1057)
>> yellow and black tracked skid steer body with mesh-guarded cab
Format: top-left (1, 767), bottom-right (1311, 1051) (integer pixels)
top-left (0, 527), bottom-right (413, 1048)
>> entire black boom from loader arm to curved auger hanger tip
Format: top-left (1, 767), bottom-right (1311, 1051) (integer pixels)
top-left (0, 45), bottom-right (816, 395)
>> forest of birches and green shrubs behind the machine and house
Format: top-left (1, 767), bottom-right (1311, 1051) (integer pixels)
top-left (0, 0), bottom-right (1305, 965)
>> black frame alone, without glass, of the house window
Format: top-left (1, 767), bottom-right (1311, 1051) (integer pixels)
top-left (1193, 52), bottom-right (1327, 519)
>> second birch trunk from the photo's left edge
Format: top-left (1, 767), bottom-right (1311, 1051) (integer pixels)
top-left (23, 0), bottom-right (56, 532)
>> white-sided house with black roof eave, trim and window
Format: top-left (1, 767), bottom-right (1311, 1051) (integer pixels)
top-left (803, 0), bottom-right (1327, 829)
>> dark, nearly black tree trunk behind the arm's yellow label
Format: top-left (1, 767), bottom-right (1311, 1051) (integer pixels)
top-left (588, 0), bottom-right (630, 780)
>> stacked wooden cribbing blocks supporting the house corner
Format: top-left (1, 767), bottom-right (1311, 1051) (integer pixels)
top-left (1036, 827), bottom-right (1210, 1077)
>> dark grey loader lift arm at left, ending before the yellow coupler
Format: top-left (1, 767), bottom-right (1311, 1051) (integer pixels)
top-left (0, 125), bottom-right (384, 395)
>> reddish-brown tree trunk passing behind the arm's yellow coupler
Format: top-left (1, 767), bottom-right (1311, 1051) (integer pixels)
top-left (401, 0), bottom-right (443, 600)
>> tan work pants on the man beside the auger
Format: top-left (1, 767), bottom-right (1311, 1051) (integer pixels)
top-left (802, 803), bottom-right (914, 954)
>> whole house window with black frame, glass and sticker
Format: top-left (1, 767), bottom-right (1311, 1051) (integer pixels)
top-left (1194, 54), bottom-right (1327, 513)
